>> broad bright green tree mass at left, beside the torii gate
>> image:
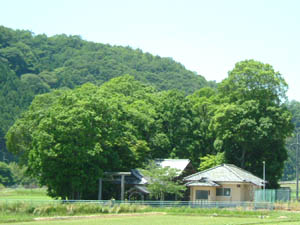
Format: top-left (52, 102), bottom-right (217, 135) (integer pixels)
top-left (6, 76), bottom-right (158, 199)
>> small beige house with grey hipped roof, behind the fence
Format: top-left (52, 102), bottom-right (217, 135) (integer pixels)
top-left (184, 164), bottom-right (264, 201)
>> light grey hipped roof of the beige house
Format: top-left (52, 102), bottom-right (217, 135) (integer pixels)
top-left (184, 164), bottom-right (263, 186)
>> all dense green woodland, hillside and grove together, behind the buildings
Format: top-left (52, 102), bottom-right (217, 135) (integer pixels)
top-left (0, 27), bottom-right (299, 199)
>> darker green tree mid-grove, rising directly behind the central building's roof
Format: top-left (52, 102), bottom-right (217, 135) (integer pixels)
top-left (150, 90), bottom-right (192, 158)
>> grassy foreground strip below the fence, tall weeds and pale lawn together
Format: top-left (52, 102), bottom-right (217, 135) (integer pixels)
top-left (0, 202), bottom-right (300, 225)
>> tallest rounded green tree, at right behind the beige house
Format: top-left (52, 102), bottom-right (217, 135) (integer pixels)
top-left (210, 60), bottom-right (293, 187)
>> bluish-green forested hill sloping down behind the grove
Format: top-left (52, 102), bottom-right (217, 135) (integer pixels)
top-left (0, 26), bottom-right (215, 160)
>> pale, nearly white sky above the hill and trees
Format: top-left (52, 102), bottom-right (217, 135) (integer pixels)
top-left (0, 0), bottom-right (300, 101)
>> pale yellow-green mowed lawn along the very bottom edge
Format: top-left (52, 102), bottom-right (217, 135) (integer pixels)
top-left (5, 215), bottom-right (300, 225)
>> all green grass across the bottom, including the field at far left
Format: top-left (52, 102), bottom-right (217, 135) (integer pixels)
top-left (0, 188), bottom-right (300, 225)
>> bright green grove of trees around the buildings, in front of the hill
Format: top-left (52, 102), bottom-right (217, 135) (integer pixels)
top-left (6, 60), bottom-right (294, 199)
